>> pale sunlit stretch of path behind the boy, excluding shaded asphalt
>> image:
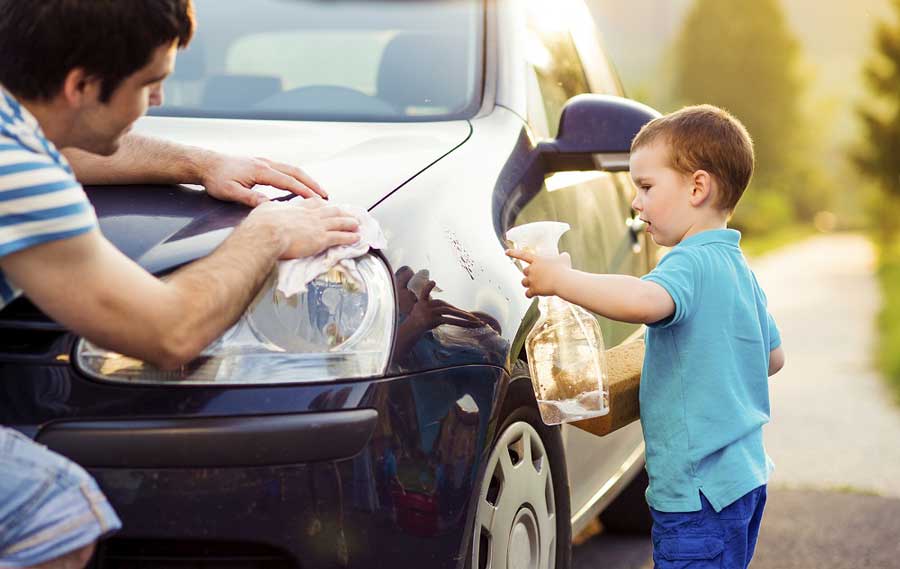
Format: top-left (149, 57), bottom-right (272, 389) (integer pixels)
top-left (753, 235), bottom-right (900, 497)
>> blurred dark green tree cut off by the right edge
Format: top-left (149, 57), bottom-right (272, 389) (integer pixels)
top-left (855, 0), bottom-right (900, 241)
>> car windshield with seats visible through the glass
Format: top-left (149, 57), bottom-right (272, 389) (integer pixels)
top-left (150, 0), bottom-right (484, 121)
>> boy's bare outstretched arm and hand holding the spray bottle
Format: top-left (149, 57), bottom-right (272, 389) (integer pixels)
top-left (506, 249), bottom-right (675, 324)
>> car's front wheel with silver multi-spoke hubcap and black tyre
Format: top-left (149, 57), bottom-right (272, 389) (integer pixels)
top-left (467, 398), bottom-right (572, 569)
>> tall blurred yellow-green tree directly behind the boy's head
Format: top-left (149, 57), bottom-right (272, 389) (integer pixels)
top-left (673, 0), bottom-right (822, 231)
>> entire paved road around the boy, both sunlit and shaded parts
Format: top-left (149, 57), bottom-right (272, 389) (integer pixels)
top-left (574, 235), bottom-right (900, 569)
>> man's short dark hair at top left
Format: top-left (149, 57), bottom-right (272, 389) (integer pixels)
top-left (0, 0), bottom-right (194, 103)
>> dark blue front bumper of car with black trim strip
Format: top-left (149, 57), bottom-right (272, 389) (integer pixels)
top-left (19, 366), bottom-right (505, 569)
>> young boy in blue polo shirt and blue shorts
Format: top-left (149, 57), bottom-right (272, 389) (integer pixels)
top-left (507, 105), bottom-right (784, 569)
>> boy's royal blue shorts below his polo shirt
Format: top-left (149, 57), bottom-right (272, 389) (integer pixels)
top-left (650, 486), bottom-right (766, 569)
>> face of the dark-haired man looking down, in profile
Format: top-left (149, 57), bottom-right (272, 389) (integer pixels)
top-left (72, 42), bottom-right (177, 156)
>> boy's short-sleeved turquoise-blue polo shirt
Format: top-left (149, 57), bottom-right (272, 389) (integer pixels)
top-left (640, 229), bottom-right (781, 512)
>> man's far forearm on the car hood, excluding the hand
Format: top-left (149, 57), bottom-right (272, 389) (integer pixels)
top-left (62, 133), bottom-right (209, 185)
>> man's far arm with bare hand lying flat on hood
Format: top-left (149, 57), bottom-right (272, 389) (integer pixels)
top-left (62, 133), bottom-right (328, 207)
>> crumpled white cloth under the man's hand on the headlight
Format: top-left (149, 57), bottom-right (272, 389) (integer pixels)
top-left (278, 198), bottom-right (387, 298)
